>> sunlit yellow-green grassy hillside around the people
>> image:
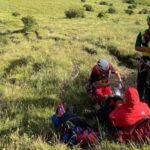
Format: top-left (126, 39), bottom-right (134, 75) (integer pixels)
top-left (0, 0), bottom-right (150, 150)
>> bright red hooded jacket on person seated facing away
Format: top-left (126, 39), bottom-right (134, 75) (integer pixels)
top-left (109, 88), bottom-right (150, 127)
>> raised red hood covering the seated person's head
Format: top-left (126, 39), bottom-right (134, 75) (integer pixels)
top-left (125, 88), bottom-right (140, 107)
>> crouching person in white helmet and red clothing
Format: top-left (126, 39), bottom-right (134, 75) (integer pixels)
top-left (88, 59), bottom-right (121, 104)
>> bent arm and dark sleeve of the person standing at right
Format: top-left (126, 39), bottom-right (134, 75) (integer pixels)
top-left (135, 32), bottom-right (150, 54)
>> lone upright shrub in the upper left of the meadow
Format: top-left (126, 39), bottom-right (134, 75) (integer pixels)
top-left (21, 16), bottom-right (39, 32)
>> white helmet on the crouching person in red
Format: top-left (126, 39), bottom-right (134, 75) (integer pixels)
top-left (97, 59), bottom-right (109, 71)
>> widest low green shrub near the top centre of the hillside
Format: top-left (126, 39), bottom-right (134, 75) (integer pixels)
top-left (65, 8), bottom-right (85, 18)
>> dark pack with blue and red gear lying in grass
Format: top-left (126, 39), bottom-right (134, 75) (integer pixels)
top-left (52, 104), bottom-right (100, 145)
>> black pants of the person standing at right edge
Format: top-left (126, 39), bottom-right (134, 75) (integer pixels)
top-left (137, 57), bottom-right (150, 105)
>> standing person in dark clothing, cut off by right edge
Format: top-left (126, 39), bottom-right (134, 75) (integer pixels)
top-left (135, 15), bottom-right (150, 101)
